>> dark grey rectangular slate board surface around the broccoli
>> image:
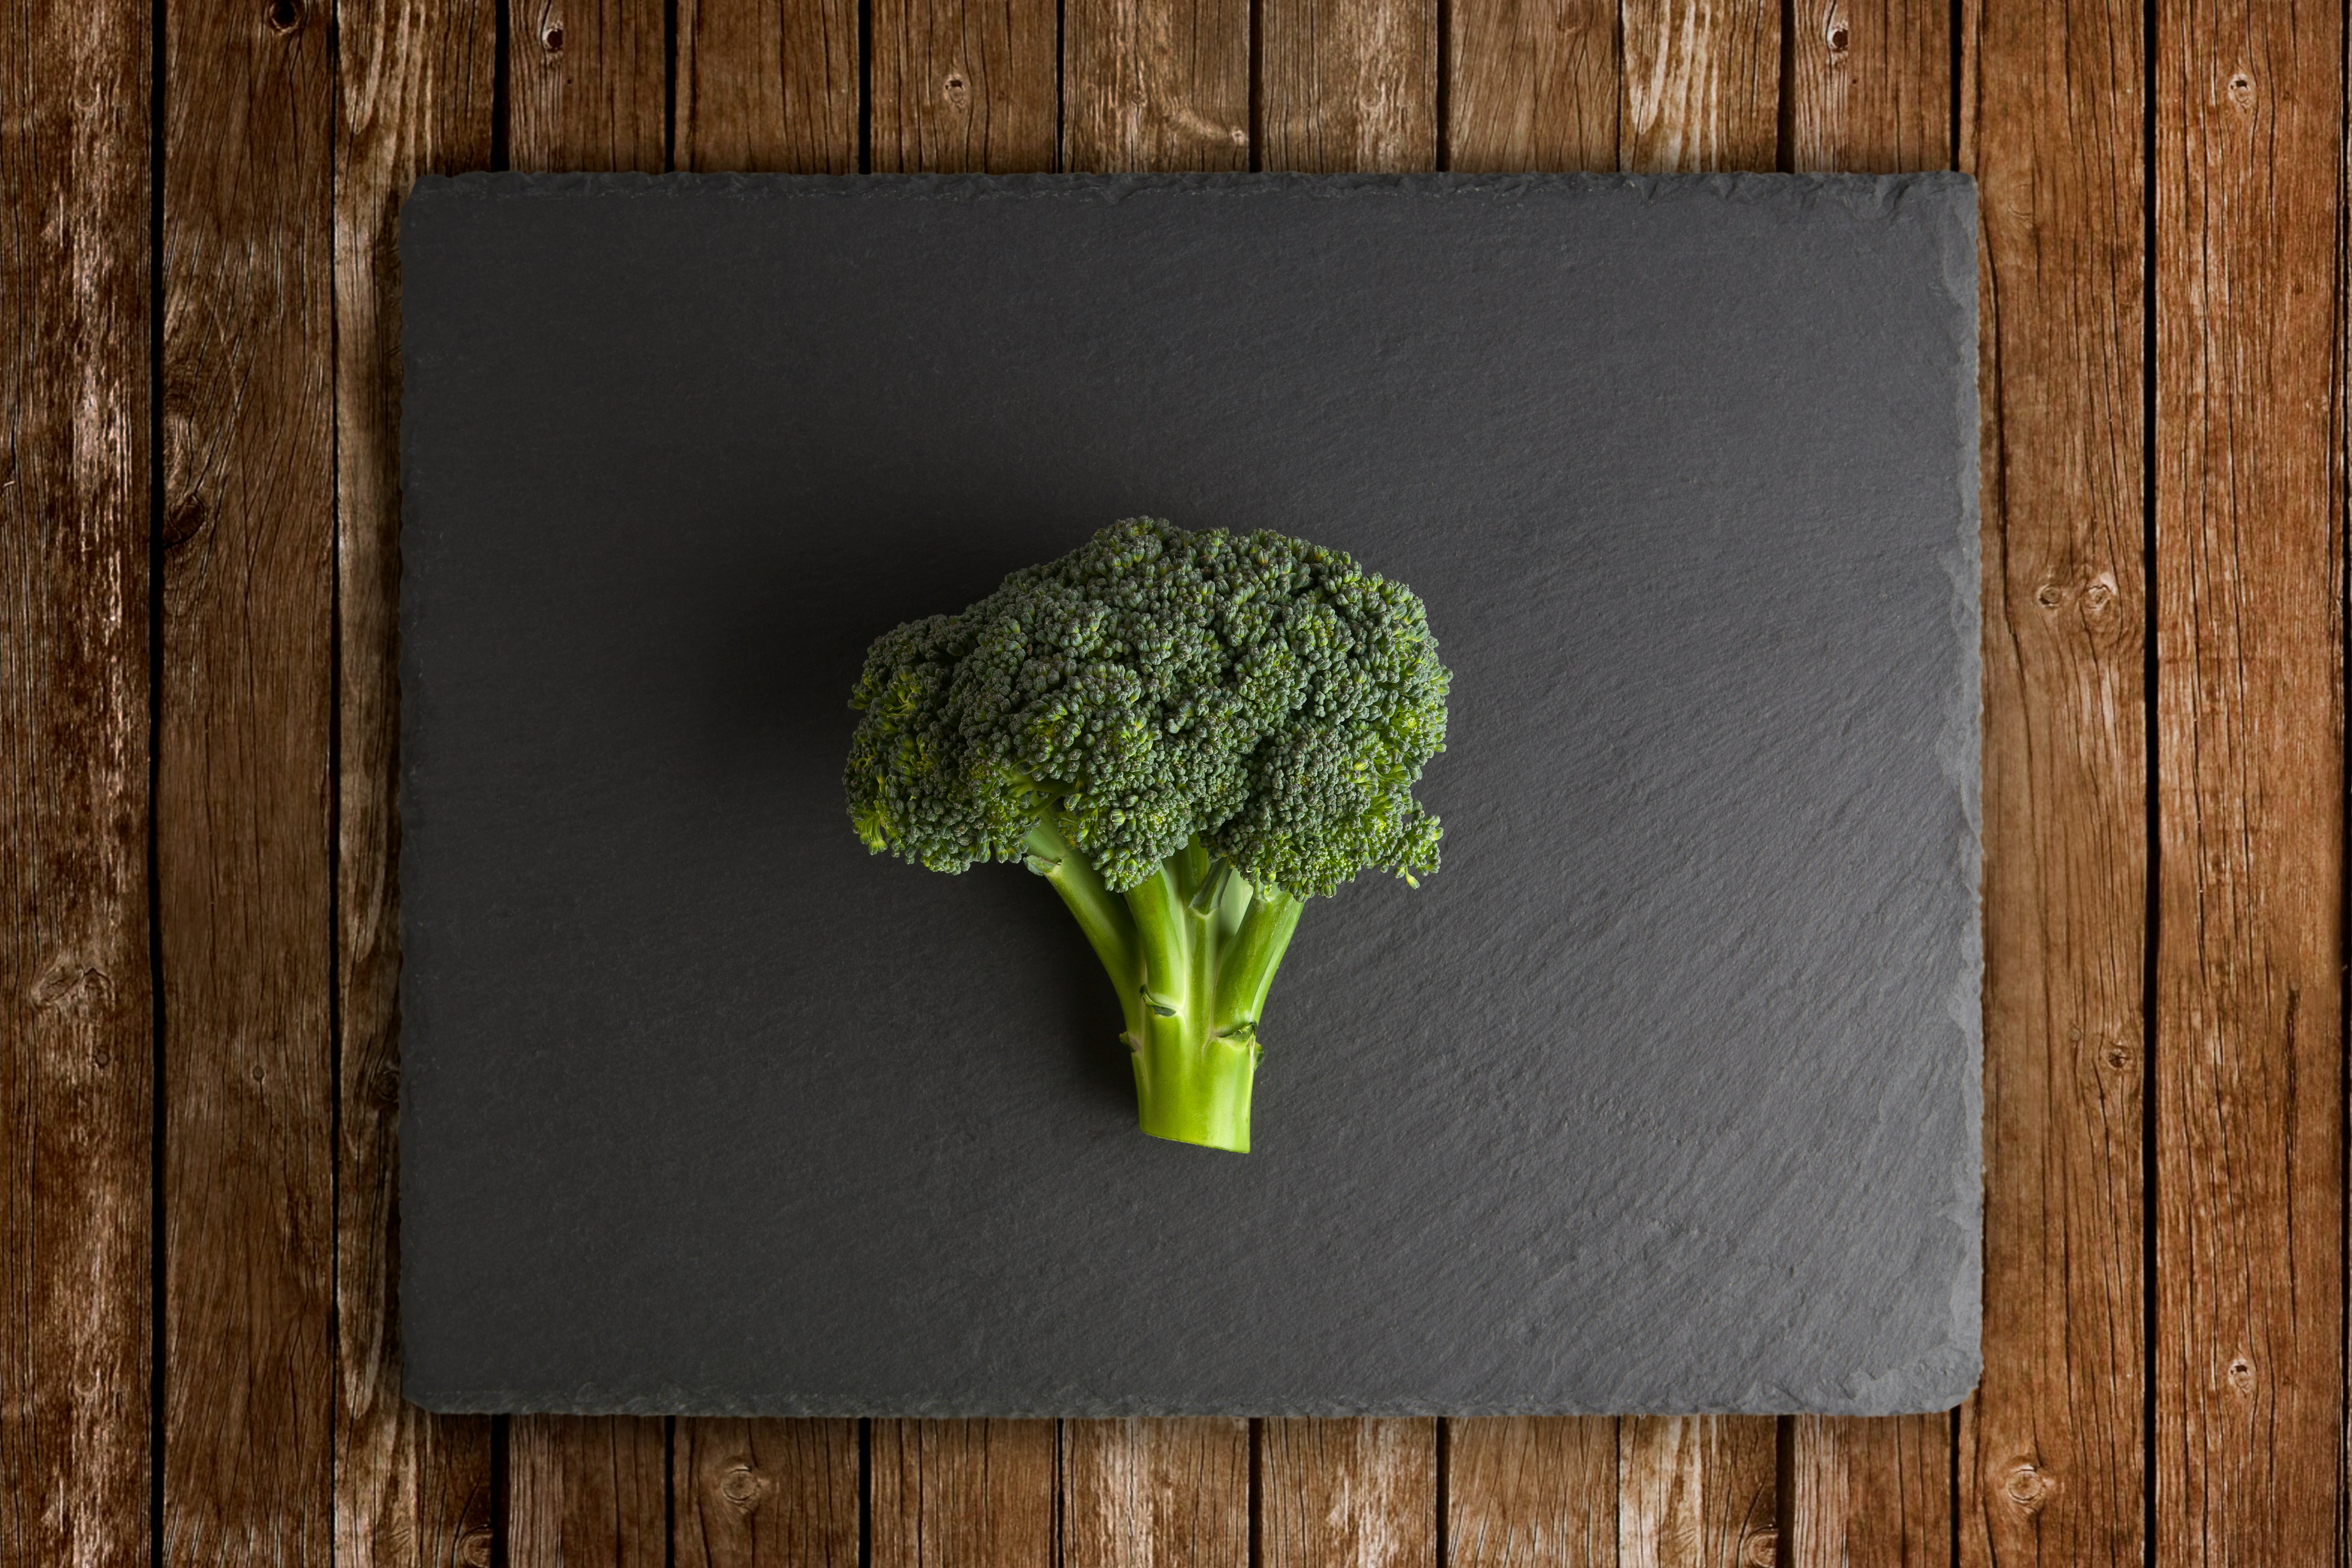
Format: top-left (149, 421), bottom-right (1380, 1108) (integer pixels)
top-left (400, 174), bottom-right (1981, 1415)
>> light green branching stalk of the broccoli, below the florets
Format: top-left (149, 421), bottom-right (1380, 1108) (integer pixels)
top-left (1023, 820), bottom-right (1305, 1154)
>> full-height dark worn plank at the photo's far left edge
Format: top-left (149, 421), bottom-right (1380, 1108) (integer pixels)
top-left (0, 0), bottom-right (155, 1563)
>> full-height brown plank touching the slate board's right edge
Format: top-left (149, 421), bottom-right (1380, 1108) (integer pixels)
top-left (1959, 0), bottom-right (2150, 1568)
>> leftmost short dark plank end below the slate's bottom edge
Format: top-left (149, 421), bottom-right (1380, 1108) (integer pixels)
top-left (505, 1415), bottom-right (671, 1568)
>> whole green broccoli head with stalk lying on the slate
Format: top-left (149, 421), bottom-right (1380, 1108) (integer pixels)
top-left (844, 517), bottom-right (1451, 1152)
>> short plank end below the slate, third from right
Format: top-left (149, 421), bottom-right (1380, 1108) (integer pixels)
top-left (1447, 1415), bottom-right (1618, 1568)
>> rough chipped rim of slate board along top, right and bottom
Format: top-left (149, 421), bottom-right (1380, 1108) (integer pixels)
top-left (402, 172), bottom-right (1985, 1418)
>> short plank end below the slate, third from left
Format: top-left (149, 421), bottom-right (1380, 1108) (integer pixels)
top-left (868, 1420), bottom-right (1054, 1568)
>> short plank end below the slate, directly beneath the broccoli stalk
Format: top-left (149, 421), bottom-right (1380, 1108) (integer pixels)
top-left (1061, 1420), bottom-right (1249, 1568)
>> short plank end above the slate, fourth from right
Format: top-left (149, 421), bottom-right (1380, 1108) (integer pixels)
top-left (1259, 0), bottom-right (1437, 174)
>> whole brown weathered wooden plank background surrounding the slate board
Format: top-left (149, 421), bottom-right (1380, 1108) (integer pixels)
top-left (0, 0), bottom-right (2347, 1568)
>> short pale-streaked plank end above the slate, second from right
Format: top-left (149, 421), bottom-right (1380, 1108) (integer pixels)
top-left (1618, 0), bottom-right (1780, 174)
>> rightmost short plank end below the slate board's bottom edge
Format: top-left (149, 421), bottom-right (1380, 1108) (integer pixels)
top-left (1780, 1415), bottom-right (1952, 1568)
